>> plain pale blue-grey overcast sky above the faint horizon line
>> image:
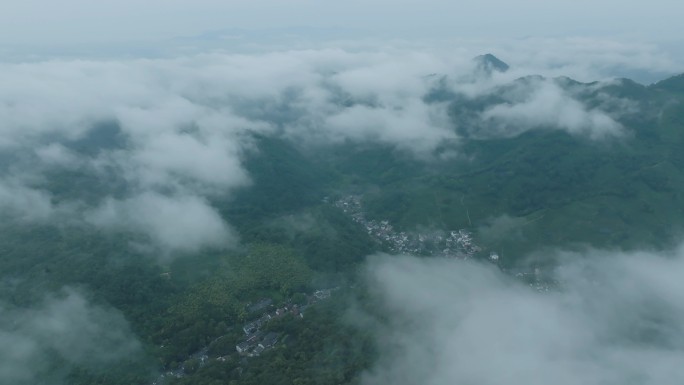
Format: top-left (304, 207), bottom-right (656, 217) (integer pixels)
top-left (0, 0), bottom-right (684, 45)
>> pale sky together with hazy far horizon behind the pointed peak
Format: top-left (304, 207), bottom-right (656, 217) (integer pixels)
top-left (0, 0), bottom-right (684, 84)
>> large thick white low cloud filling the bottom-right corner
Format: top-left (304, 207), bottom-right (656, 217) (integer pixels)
top-left (362, 249), bottom-right (684, 385)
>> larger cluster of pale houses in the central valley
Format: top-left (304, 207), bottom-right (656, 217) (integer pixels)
top-left (332, 195), bottom-right (481, 259)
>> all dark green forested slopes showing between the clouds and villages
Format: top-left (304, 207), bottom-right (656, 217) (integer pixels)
top-left (0, 67), bottom-right (684, 384)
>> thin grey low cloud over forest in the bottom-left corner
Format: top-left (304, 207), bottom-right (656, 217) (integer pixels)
top-left (0, 289), bottom-right (140, 385)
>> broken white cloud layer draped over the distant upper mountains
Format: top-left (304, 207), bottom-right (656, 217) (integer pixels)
top-left (0, 46), bottom-right (664, 251)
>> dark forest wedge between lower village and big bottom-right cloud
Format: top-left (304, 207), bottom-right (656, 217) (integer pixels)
top-left (170, 301), bottom-right (375, 385)
